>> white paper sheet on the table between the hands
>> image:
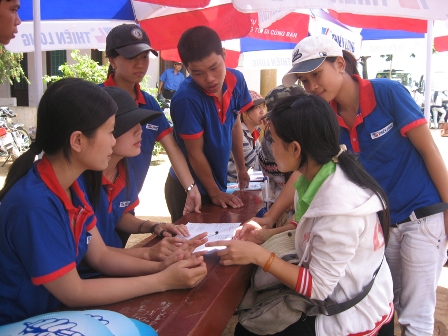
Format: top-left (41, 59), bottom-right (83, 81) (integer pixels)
top-left (179, 222), bottom-right (241, 253)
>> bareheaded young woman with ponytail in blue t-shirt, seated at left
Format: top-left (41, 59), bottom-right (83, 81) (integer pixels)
top-left (0, 78), bottom-right (207, 325)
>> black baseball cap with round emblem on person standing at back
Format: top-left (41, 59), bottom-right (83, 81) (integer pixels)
top-left (106, 23), bottom-right (159, 59)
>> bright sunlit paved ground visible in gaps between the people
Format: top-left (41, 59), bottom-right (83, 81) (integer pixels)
top-left (0, 130), bottom-right (448, 336)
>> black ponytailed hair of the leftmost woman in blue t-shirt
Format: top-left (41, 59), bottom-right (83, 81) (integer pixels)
top-left (0, 78), bottom-right (117, 200)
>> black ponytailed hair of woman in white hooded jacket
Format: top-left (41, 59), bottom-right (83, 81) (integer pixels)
top-left (269, 93), bottom-right (390, 244)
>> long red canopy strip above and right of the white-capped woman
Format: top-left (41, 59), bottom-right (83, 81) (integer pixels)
top-left (328, 10), bottom-right (427, 33)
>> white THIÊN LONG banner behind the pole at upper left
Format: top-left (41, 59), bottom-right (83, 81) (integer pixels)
top-left (5, 20), bottom-right (134, 53)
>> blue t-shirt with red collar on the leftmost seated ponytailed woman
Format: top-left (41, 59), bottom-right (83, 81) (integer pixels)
top-left (0, 155), bottom-right (96, 325)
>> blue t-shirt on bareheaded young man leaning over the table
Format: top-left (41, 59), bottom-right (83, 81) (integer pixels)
top-left (170, 69), bottom-right (252, 195)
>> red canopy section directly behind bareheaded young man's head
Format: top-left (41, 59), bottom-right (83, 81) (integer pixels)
top-left (140, 4), bottom-right (251, 50)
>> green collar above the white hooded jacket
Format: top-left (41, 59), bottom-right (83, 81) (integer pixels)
top-left (294, 161), bottom-right (336, 223)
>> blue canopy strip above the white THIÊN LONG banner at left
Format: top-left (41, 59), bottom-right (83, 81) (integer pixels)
top-left (19, 0), bottom-right (135, 21)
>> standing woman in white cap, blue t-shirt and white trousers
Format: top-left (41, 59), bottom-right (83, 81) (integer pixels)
top-left (283, 35), bottom-right (448, 335)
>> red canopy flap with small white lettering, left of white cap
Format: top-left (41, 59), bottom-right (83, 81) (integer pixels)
top-left (247, 13), bottom-right (310, 43)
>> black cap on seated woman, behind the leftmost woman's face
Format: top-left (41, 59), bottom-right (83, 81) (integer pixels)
top-left (104, 86), bottom-right (163, 138)
